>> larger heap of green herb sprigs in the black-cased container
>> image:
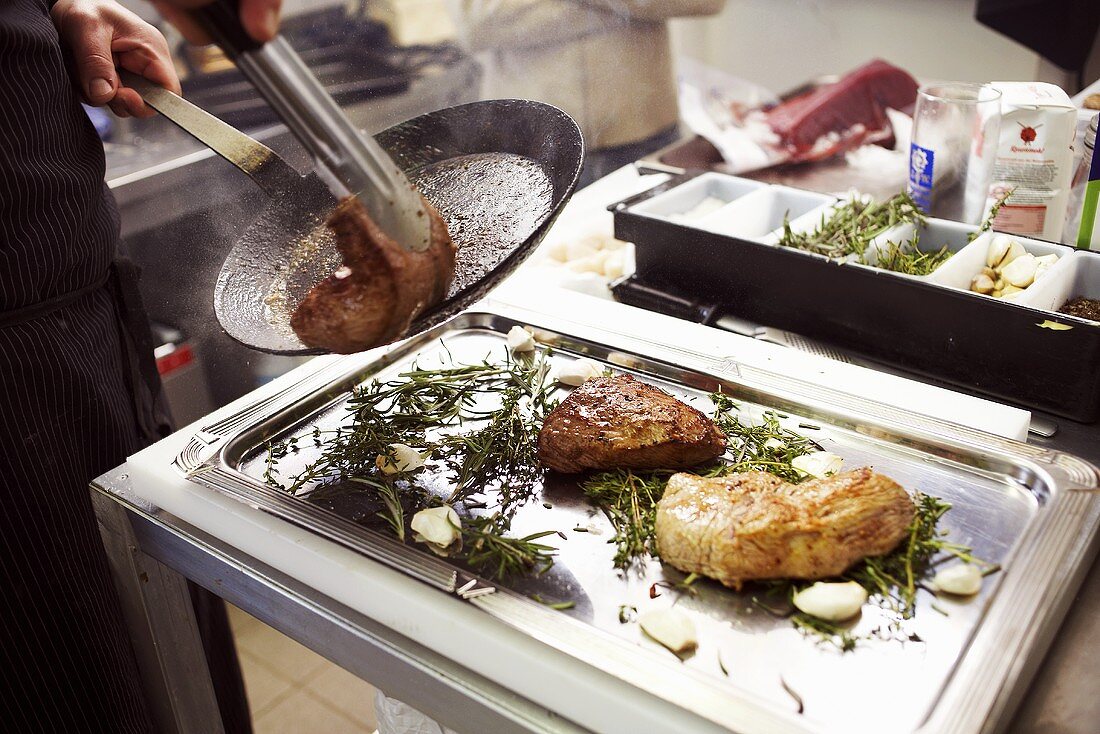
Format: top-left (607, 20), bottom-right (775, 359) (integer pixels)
top-left (779, 193), bottom-right (925, 262)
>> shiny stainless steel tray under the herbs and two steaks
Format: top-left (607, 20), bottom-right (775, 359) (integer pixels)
top-left (175, 310), bottom-right (1100, 732)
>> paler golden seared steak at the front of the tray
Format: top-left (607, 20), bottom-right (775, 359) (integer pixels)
top-left (657, 468), bottom-right (914, 589)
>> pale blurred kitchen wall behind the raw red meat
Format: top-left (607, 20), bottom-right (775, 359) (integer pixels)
top-left (673, 0), bottom-right (1047, 91)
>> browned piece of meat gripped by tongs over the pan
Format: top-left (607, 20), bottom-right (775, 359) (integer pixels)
top-left (290, 196), bottom-right (455, 354)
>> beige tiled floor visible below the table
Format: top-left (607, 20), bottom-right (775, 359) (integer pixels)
top-left (229, 605), bottom-right (376, 734)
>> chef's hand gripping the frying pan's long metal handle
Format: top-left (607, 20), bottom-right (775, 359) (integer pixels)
top-left (50, 0), bottom-right (179, 118)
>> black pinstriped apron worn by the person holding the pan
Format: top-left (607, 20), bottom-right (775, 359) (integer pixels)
top-left (0, 0), bottom-right (249, 732)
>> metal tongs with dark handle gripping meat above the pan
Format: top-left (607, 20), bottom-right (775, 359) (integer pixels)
top-left (193, 0), bottom-right (430, 250)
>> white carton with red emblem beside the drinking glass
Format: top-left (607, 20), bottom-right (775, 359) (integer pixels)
top-left (986, 81), bottom-right (1077, 242)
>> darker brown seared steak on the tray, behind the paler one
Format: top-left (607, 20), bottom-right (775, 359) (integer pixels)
top-left (539, 375), bottom-right (726, 474)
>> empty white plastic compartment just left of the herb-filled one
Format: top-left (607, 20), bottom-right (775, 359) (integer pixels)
top-left (695, 186), bottom-right (834, 241)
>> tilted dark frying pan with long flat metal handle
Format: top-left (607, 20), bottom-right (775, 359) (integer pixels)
top-left (122, 73), bottom-right (584, 354)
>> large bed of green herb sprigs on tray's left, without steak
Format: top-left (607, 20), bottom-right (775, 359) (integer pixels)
top-left (263, 347), bottom-right (557, 578)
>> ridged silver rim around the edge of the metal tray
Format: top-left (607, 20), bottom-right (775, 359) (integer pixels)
top-left (173, 306), bottom-right (1100, 732)
